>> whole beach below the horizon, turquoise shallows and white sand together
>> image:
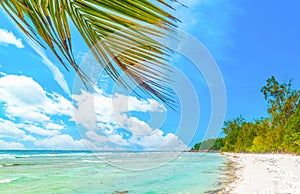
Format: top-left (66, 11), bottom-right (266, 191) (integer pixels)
top-left (0, 151), bottom-right (300, 194)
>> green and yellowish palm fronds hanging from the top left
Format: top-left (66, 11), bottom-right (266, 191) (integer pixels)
top-left (0, 0), bottom-right (178, 104)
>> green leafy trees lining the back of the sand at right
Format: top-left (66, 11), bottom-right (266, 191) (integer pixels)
top-left (193, 77), bottom-right (300, 154)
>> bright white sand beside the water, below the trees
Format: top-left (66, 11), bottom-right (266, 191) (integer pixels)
top-left (225, 153), bottom-right (300, 194)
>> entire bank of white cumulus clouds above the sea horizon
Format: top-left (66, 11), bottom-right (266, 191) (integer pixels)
top-left (0, 75), bottom-right (185, 150)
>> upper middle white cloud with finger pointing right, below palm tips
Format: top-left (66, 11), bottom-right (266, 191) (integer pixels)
top-left (73, 89), bottom-right (166, 129)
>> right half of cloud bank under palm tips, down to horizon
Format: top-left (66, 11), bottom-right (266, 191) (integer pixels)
top-left (73, 89), bottom-right (186, 150)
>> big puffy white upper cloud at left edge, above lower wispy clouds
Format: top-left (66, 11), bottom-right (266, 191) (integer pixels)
top-left (0, 75), bottom-right (72, 121)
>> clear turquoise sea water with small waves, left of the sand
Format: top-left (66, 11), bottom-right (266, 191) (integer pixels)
top-left (0, 151), bottom-right (226, 194)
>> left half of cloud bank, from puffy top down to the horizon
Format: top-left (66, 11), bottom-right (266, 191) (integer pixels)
top-left (0, 75), bottom-right (75, 149)
